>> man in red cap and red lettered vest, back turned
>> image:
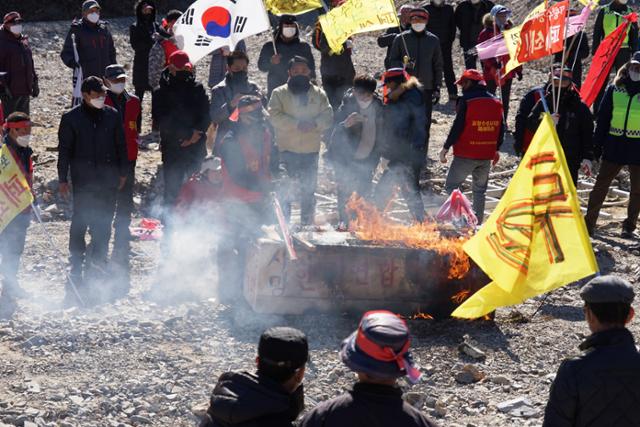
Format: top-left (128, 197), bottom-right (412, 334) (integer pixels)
top-left (440, 70), bottom-right (504, 223)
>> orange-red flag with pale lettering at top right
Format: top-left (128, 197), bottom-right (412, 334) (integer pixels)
top-left (518, 0), bottom-right (569, 63)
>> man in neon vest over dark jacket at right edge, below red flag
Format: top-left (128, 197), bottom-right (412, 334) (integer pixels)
top-left (585, 52), bottom-right (640, 239)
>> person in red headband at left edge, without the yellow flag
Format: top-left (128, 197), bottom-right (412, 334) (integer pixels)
top-left (0, 112), bottom-right (33, 319)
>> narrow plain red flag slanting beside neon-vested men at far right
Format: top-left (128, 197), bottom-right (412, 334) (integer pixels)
top-left (580, 12), bottom-right (638, 107)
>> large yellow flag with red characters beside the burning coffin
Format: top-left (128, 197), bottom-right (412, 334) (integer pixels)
top-left (452, 113), bottom-right (598, 319)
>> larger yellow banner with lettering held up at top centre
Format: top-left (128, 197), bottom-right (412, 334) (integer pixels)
top-left (320, 0), bottom-right (400, 53)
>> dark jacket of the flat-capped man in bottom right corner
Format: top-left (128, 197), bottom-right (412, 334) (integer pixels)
top-left (543, 328), bottom-right (640, 427)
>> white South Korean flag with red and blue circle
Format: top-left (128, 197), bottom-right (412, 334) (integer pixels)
top-left (173, 0), bottom-right (271, 64)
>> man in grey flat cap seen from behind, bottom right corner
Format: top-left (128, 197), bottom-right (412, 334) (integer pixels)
top-left (543, 276), bottom-right (640, 427)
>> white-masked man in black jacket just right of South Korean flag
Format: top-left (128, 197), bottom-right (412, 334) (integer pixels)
top-left (258, 15), bottom-right (316, 98)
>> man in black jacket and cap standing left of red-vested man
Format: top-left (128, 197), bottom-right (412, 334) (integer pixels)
top-left (58, 76), bottom-right (128, 305)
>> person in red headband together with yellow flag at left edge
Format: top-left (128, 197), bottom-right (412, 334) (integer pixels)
top-left (0, 112), bottom-right (33, 319)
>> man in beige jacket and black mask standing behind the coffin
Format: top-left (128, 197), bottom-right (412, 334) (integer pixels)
top-left (269, 56), bottom-right (333, 225)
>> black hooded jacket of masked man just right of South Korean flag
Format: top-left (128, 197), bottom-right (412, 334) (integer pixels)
top-left (258, 22), bottom-right (316, 97)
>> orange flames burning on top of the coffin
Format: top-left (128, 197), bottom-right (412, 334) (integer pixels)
top-left (347, 194), bottom-right (471, 279)
